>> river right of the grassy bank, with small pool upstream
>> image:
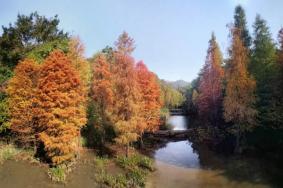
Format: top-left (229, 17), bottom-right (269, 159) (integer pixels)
top-left (147, 116), bottom-right (282, 188)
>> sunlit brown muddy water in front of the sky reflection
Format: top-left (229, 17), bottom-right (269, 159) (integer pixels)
top-left (146, 161), bottom-right (272, 188)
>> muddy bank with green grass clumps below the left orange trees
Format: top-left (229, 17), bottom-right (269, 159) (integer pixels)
top-left (0, 143), bottom-right (154, 188)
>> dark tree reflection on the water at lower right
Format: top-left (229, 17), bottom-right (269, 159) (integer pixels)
top-left (192, 143), bottom-right (283, 187)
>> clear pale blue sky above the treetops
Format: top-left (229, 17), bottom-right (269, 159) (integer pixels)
top-left (0, 0), bottom-right (283, 81)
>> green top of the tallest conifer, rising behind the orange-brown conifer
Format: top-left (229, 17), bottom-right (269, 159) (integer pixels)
top-left (234, 5), bottom-right (252, 49)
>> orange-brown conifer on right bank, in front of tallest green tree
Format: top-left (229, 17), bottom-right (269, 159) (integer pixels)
top-left (224, 28), bottom-right (256, 152)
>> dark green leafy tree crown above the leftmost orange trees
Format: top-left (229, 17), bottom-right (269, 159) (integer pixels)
top-left (0, 12), bottom-right (69, 67)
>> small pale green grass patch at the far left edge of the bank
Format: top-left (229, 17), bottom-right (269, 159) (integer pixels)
top-left (0, 144), bottom-right (21, 163)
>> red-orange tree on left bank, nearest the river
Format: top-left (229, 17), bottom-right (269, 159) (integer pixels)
top-left (135, 61), bottom-right (161, 143)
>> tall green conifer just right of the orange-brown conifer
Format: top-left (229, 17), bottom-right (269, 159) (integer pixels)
top-left (252, 15), bottom-right (278, 125)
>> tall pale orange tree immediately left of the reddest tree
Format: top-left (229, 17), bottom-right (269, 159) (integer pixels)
top-left (111, 53), bottom-right (142, 156)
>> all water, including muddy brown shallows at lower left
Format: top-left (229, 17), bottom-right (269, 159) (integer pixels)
top-left (0, 116), bottom-right (283, 188)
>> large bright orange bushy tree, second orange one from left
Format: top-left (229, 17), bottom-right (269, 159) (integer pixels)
top-left (37, 50), bottom-right (86, 165)
